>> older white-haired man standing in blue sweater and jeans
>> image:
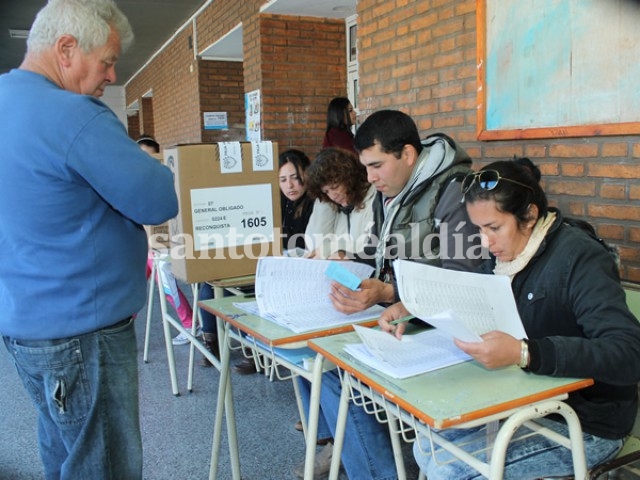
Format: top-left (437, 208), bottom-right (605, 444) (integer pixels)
top-left (0, 0), bottom-right (178, 479)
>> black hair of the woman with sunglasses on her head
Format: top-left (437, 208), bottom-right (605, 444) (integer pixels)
top-left (463, 157), bottom-right (549, 226)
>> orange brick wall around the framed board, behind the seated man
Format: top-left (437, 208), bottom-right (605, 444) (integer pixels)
top-left (358, 0), bottom-right (640, 282)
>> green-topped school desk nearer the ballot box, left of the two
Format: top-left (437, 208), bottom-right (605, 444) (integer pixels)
top-left (198, 297), bottom-right (377, 480)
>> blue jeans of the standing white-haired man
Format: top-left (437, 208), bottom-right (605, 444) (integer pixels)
top-left (4, 319), bottom-right (142, 480)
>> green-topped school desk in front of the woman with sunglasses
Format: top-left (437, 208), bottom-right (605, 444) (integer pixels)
top-left (309, 332), bottom-right (593, 479)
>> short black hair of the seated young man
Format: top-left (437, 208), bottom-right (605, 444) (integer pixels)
top-left (354, 110), bottom-right (422, 158)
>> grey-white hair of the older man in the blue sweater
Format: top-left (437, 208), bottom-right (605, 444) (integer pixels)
top-left (27, 0), bottom-right (133, 53)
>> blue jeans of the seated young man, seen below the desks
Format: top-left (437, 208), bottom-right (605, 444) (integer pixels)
top-left (301, 370), bottom-right (397, 480)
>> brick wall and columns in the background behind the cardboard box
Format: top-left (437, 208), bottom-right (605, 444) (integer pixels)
top-left (126, 1), bottom-right (346, 157)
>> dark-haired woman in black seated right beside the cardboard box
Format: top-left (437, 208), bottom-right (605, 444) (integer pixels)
top-left (278, 149), bottom-right (313, 250)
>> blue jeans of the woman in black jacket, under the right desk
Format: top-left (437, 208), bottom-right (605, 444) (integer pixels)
top-left (413, 418), bottom-right (623, 480)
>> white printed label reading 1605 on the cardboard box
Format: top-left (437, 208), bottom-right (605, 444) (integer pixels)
top-left (191, 184), bottom-right (274, 251)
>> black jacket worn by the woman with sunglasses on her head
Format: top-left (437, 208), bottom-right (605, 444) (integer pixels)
top-left (481, 210), bottom-right (640, 439)
